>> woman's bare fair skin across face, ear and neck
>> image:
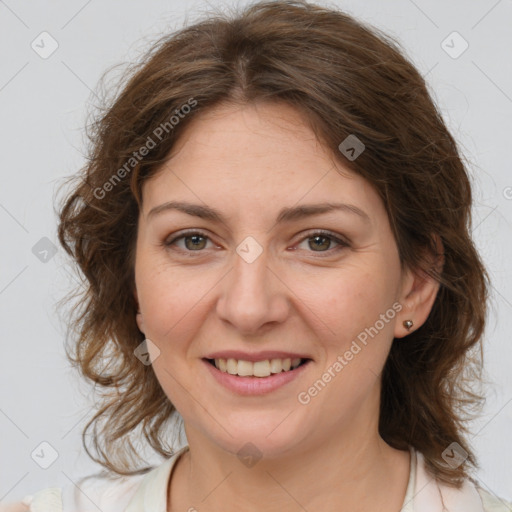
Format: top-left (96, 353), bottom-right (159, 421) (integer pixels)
top-left (134, 103), bottom-right (438, 512)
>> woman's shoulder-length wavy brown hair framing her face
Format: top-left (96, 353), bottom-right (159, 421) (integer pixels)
top-left (58, 1), bottom-right (489, 487)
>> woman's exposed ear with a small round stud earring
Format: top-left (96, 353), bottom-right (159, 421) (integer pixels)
top-left (394, 235), bottom-right (444, 338)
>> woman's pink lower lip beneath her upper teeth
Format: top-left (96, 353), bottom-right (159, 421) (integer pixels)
top-left (202, 359), bottom-right (311, 395)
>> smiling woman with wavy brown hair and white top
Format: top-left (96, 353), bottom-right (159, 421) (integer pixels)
top-left (3, 1), bottom-right (512, 512)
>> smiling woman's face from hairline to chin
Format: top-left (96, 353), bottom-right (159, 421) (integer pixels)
top-left (135, 104), bottom-right (422, 457)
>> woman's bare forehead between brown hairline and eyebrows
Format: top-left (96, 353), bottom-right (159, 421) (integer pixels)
top-left (143, 103), bottom-right (382, 223)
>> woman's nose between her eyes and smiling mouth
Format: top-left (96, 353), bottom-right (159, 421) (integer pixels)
top-left (216, 244), bottom-right (290, 335)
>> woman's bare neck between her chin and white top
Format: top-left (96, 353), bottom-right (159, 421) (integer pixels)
top-left (169, 432), bottom-right (410, 512)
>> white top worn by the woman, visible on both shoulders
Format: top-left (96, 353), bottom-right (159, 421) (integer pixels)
top-left (0, 445), bottom-right (512, 512)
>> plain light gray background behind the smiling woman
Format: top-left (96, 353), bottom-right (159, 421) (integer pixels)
top-left (0, 0), bottom-right (512, 501)
